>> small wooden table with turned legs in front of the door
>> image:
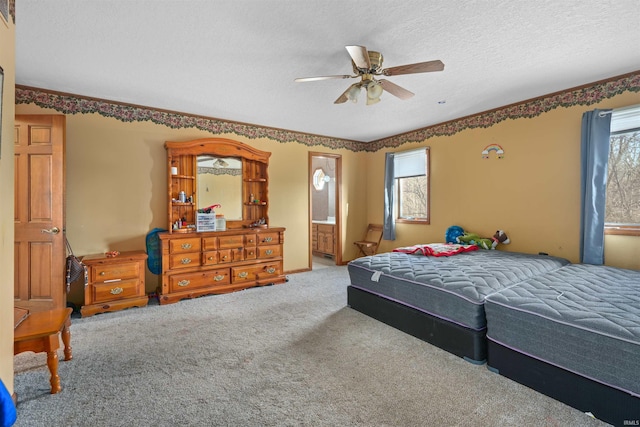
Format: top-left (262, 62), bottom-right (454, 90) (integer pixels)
top-left (13, 308), bottom-right (73, 394)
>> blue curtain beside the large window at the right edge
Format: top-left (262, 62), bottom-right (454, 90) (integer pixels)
top-left (580, 110), bottom-right (611, 264)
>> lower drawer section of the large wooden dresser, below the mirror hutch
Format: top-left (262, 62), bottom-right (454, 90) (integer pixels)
top-left (158, 228), bottom-right (287, 304)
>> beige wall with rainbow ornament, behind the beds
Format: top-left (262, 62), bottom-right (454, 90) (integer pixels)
top-left (367, 92), bottom-right (640, 269)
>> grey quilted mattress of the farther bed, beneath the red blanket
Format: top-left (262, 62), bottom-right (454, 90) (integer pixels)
top-left (348, 250), bottom-right (569, 331)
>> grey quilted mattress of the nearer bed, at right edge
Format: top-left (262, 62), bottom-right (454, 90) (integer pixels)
top-left (485, 264), bottom-right (640, 397)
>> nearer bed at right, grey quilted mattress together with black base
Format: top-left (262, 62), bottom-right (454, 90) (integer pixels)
top-left (485, 264), bottom-right (640, 425)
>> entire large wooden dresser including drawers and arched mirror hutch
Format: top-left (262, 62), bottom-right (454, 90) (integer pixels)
top-left (158, 138), bottom-right (287, 304)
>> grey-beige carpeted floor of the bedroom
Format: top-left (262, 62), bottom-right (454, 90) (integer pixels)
top-left (15, 263), bottom-right (605, 427)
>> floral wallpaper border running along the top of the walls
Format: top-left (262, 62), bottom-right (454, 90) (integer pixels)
top-left (16, 71), bottom-right (640, 152)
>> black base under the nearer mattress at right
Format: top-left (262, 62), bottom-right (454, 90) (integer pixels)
top-left (487, 340), bottom-right (640, 426)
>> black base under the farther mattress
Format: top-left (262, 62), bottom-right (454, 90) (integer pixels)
top-left (347, 286), bottom-right (487, 365)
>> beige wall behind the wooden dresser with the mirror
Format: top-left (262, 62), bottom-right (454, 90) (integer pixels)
top-left (11, 104), bottom-right (366, 303)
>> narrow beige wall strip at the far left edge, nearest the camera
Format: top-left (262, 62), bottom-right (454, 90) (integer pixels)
top-left (0, 13), bottom-right (15, 393)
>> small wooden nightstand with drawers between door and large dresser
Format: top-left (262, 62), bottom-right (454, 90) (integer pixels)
top-left (80, 251), bottom-right (149, 317)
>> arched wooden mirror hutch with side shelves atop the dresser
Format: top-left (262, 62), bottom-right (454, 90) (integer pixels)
top-left (165, 138), bottom-right (271, 233)
